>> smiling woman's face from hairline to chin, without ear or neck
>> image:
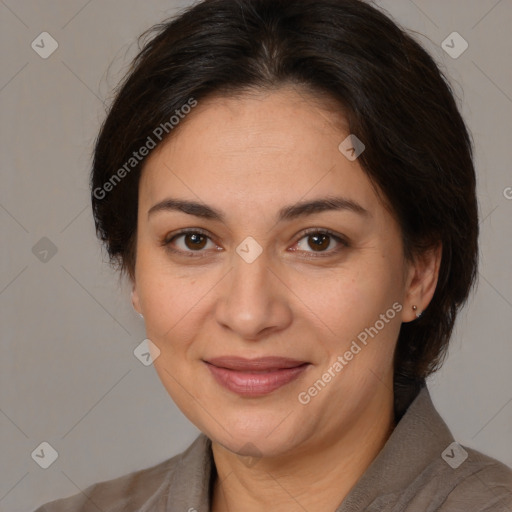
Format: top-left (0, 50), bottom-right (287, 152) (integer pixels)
top-left (133, 87), bottom-right (420, 456)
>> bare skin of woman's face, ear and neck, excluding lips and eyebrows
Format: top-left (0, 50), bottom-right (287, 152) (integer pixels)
top-left (132, 86), bottom-right (441, 512)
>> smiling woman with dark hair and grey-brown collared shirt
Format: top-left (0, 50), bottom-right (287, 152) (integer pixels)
top-left (34, 0), bottom-right (512, 512)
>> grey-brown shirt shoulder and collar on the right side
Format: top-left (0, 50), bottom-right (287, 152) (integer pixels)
top-left (354, 387), bottom-right (512, 512)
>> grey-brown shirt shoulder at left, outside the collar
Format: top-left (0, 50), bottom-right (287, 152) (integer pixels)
top-left (34, 440), bottom-right (190, 512)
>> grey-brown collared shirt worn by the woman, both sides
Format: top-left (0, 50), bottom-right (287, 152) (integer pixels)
top-left (35, 387), bottom-right (512, 512)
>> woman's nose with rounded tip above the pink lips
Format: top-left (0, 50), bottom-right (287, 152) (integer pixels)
top-left (215, 246), bottom-right (292, 341)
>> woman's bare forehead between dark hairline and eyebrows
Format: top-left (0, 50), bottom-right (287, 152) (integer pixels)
top-left (140, 87), bottom-right (379, 218)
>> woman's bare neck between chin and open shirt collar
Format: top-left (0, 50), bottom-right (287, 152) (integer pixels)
top-left (211, 386), bottom-right (395, 512)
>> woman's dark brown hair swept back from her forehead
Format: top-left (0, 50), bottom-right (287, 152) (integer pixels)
top-left (91, 0), bottom-right (478, 396)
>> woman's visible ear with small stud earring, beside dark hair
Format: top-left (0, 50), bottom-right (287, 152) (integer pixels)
top-left (402, 242), bottom-right (442, 322)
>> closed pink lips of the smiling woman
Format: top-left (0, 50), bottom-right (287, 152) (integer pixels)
top-left (205, 356), bottom-right (309, 397)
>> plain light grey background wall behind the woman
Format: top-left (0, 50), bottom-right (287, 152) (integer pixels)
top-left (0, 0), bottom-right (512, 512)
